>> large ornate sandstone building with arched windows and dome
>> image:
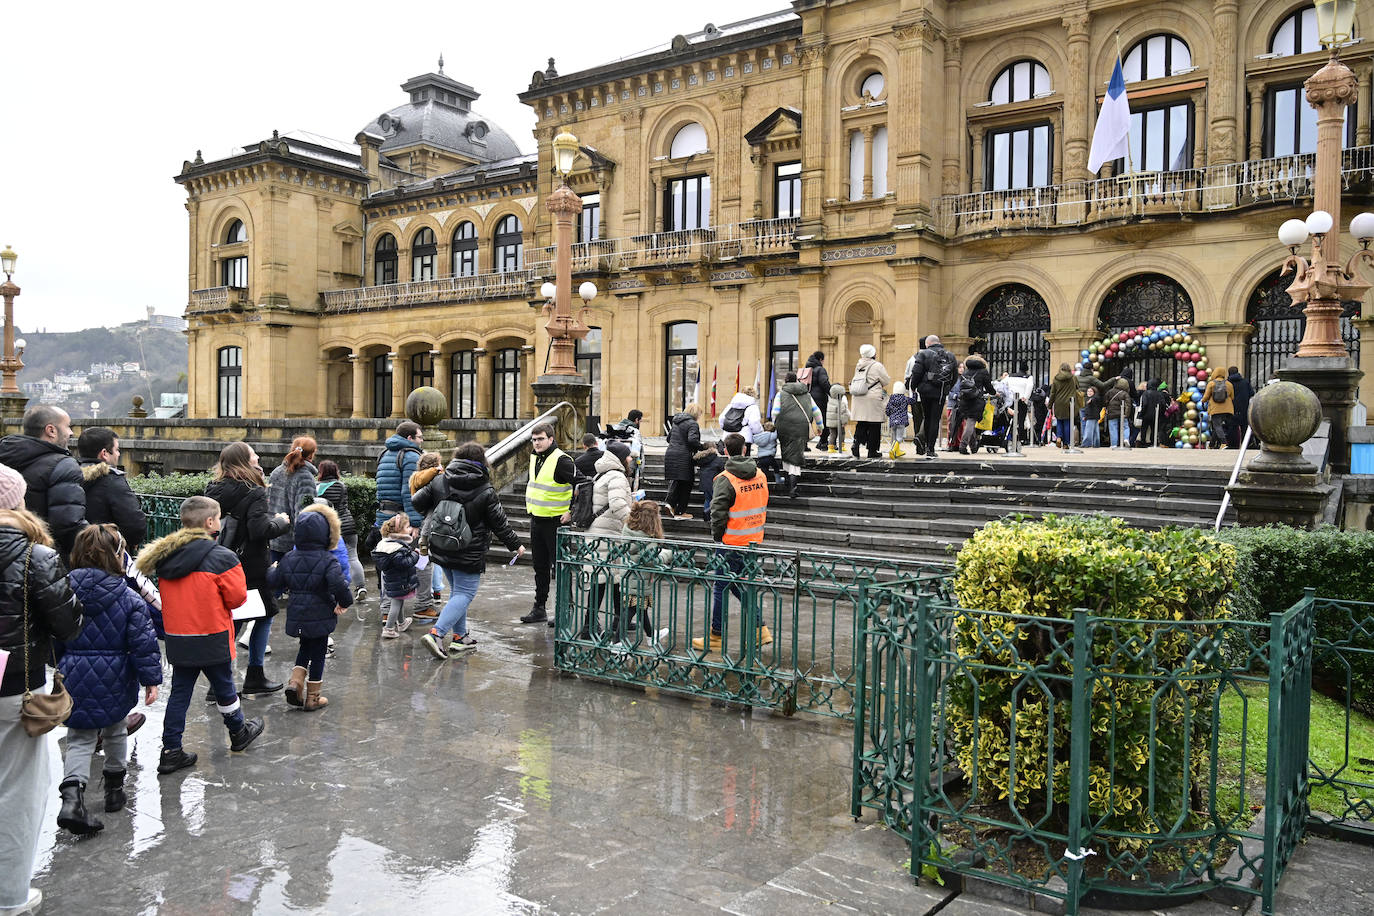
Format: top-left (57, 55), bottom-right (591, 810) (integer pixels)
top-left (177, 0), bottom-right (1374, 427)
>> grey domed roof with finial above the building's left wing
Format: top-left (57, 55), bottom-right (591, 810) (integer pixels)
top-left (363, 73), bottom-right (521, 162)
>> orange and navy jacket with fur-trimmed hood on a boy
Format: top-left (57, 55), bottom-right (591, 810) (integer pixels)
top-left (137, 527), bottom-right (249, 667)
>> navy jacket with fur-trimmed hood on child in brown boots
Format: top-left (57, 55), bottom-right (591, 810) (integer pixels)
top-left (267, 505), bottom-right (353, 639)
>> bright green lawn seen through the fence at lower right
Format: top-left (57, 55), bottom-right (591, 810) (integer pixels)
top-left (1217, 684), bottom-right (1374, 818)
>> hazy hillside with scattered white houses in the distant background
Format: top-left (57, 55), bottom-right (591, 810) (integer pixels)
top-left (15, 321), bottom-right (187, 417)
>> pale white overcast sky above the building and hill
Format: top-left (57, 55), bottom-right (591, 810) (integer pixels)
top-left (0, 0), bottom-right (789, 331)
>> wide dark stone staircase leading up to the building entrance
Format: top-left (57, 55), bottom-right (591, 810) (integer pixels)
top-left (497, 453), bottom-right (1235, 563)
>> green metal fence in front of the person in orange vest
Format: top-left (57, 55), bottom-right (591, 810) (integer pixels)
top-left (555, 530), bottom-right (949, 718)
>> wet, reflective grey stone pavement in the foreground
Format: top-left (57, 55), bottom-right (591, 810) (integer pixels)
top-left (26, 567), bottom-right (1374, 916)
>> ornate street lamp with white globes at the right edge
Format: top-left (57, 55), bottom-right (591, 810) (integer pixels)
top-left (1279, 0), bottom-right (1374, 358)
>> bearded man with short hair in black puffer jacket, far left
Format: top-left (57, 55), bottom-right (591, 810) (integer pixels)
top-left (0, 404), bottom-right (87, 563)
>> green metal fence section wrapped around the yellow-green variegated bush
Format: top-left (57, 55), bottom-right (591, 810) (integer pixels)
top-left (851, 584), bottom-right (1314, 913)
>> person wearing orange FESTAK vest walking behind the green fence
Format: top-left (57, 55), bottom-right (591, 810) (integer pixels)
top-left (691, 433), bottom-right (772, 652)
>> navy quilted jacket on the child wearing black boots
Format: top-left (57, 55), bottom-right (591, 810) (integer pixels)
top-left (56, 569), bottom-right (162, 728)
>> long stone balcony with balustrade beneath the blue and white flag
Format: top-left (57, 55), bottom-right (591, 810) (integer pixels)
top-left (933, 146), bottom-right (1374, 239)
